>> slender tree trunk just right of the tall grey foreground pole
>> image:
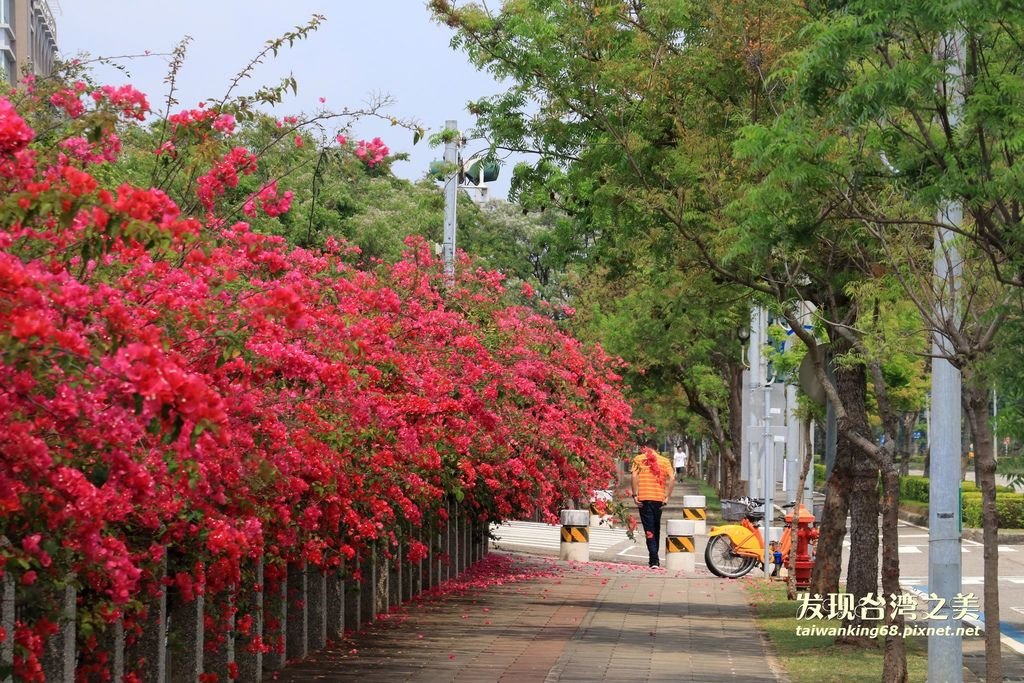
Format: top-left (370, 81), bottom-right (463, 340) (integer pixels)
top-left (964, 381), bottom-right (1002, 683)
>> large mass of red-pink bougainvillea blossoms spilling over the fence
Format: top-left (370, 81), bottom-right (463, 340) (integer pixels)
top-left (0, 89), bottom-right (632, 680)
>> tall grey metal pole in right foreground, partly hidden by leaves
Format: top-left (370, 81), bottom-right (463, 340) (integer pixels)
top-left (928, 35), bottom-right (964, 683)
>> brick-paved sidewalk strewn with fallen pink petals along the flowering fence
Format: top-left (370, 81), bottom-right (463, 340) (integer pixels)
top-left (272, 553), bottom-right (786, 683)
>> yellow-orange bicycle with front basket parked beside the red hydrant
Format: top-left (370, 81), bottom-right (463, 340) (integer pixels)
top-left (705, 497), bottom-right (809, 579)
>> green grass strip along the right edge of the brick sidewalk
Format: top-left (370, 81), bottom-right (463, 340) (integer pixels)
top-left (742, 581), bottom-right (928, 683)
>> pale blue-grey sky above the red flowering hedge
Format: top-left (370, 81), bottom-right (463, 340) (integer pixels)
top-left (57, 0), bottom-right (520, 197)
